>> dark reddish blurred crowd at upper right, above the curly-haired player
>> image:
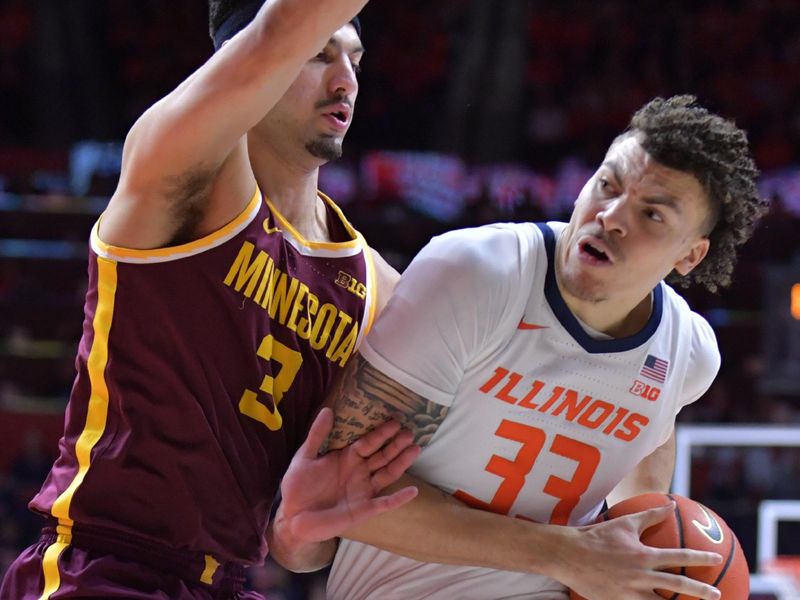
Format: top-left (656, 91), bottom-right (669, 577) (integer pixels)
top-left (527, 0), bottom-right (800, 170)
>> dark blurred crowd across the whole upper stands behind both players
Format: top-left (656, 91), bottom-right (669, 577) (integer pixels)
top-left (0, 0), bottom-right (800, 178)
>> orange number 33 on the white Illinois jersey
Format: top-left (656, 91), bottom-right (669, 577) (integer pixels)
top-left (454, 419), bottom-right (600, 525)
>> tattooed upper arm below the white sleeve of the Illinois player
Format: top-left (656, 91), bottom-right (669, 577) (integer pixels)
top-left (330, 355), bottom-right (447, 448)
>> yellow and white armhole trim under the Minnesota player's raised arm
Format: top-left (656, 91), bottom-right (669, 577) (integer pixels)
top-left (92, 188), bottom-right (261, 262)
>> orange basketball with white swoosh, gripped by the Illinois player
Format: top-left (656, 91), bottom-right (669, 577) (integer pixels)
top-left (570, 494), bottom-right (750, 600)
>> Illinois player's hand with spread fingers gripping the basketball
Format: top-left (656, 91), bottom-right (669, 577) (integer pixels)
top-left (558, 504), bottom-right (722, 600)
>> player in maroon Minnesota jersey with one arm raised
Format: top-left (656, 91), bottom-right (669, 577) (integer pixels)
top-left (0, 0), bottom-right (418, 600)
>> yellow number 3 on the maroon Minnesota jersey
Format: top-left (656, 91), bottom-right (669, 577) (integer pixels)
top-left (239, 335), bottom-right (303, 431)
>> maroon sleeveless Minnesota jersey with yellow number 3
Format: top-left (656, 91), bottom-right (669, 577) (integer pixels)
top-left (30, 192), bottom-right (376, 563)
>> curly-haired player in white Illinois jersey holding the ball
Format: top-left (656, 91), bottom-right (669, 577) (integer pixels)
top-left (328, 96), bottom-right (763, 600)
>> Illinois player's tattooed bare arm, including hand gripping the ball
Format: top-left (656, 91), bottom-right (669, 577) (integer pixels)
top-left (331, 356), bottom-right (721, 600)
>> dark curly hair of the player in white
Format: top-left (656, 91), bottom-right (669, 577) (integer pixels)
top-left (629, 95), bottom-right (766, 292)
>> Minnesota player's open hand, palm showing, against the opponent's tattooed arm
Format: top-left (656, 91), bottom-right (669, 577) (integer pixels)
top-left (280, 408), bottom-right (420, 544)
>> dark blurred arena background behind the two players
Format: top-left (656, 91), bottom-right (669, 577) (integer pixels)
top-left (0, 0), bottom-right (800, 599)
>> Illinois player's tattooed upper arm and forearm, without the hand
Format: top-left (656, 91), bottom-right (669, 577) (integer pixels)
top-left (330, 355), bottom-right (559, 572)
